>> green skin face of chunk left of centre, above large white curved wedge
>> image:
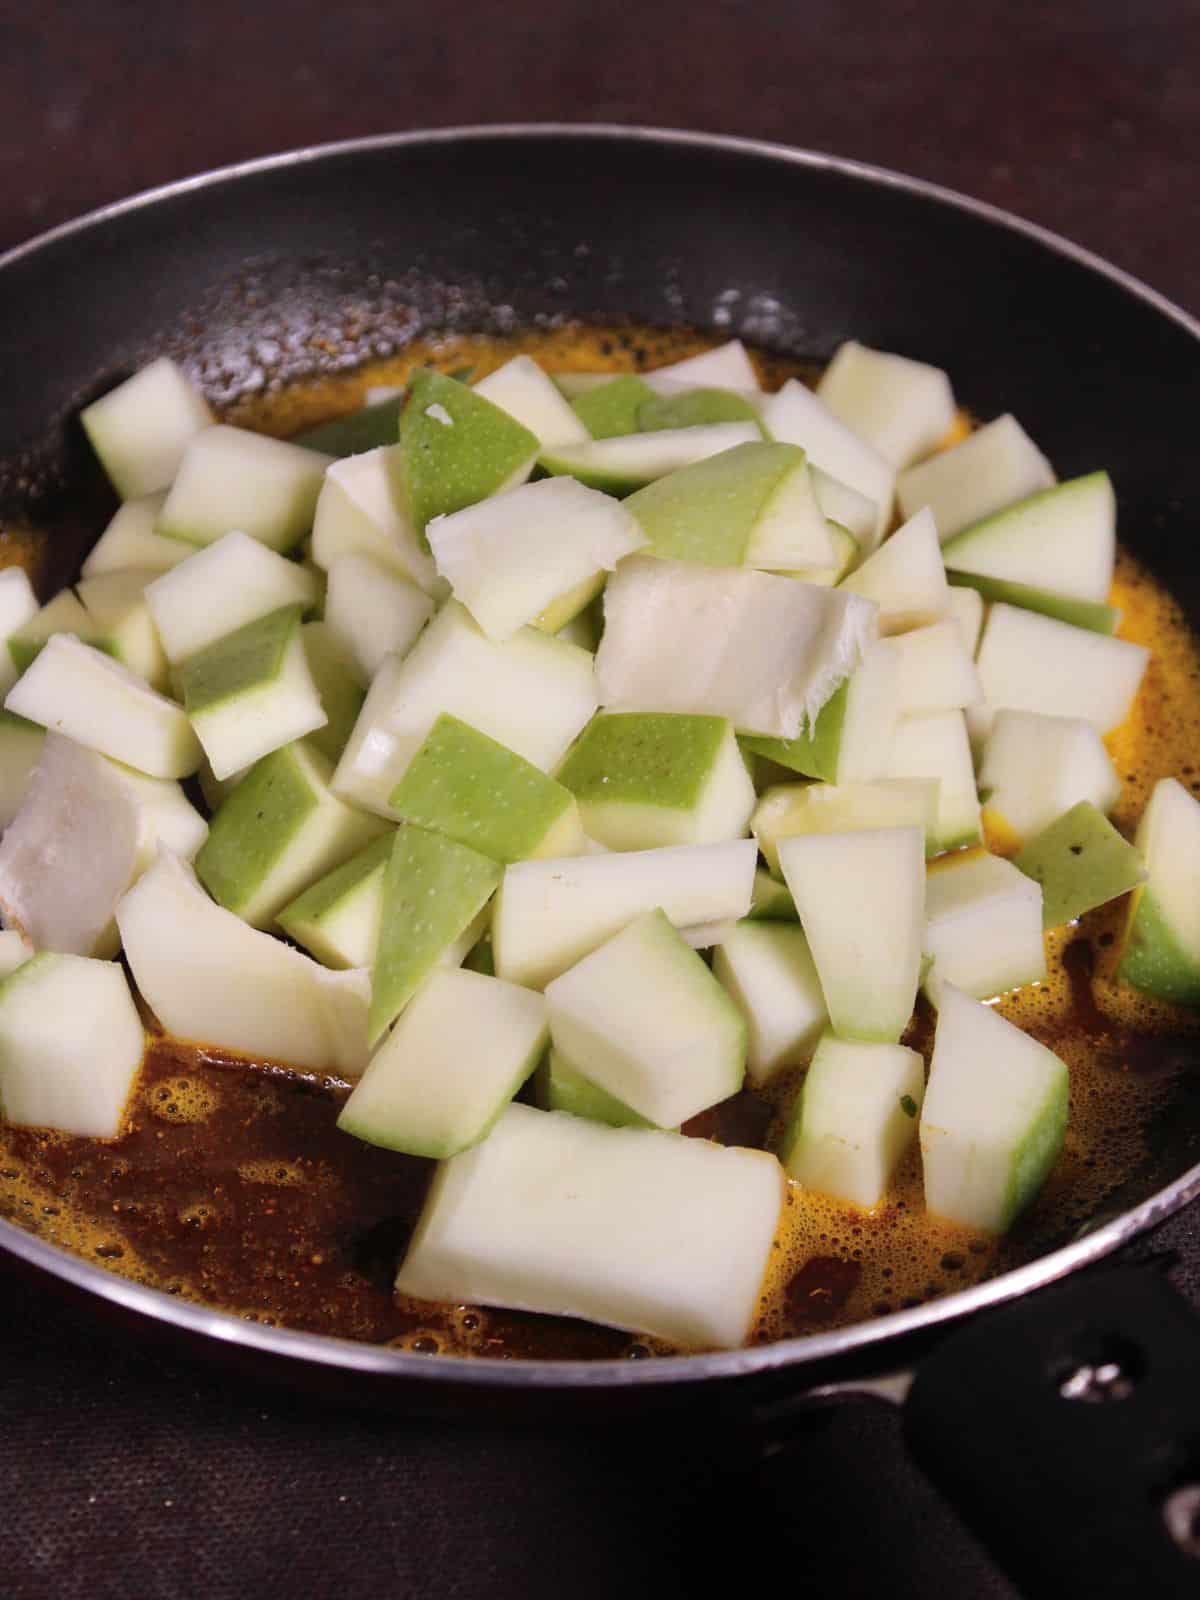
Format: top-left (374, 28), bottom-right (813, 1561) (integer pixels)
top-left (195, 744), bottom-right (320, 912)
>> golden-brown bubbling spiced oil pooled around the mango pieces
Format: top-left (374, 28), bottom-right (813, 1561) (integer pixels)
top-left (0, 326), bottom-right (1200, 1358)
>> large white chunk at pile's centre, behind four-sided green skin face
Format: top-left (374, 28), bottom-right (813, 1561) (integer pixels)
top-left (333, 600), bottom-right (597, 816)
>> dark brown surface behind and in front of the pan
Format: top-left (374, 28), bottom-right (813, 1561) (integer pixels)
top-left (0, 0), bottom-right (1200, 1600)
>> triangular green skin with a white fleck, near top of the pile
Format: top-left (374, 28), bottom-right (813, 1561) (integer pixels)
top-left (397, 370), bottom-right (541, 538)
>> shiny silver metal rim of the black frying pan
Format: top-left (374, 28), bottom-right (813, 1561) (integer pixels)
top-left (0, 122), bottom-right (1200, 1389)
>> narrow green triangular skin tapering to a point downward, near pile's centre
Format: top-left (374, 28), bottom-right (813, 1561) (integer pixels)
top-left (368, 822), bottom-right (504, 1046)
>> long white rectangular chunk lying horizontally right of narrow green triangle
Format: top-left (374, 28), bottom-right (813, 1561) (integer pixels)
top-left (491, 838), bottom-right (757, 989)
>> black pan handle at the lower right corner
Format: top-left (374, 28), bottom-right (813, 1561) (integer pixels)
top-left (904, 1267), bottom-right (1200, 1600)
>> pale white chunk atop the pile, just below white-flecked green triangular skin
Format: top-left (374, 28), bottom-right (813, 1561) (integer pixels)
top-left (426, 473), bottom-right (646, 642)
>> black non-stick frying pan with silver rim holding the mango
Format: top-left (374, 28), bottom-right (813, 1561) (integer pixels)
top-left (0, 125), bottom-right (1200, 1595)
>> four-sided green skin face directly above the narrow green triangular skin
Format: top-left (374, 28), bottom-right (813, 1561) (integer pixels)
top-left (387, 712), bottom-right (571, 862)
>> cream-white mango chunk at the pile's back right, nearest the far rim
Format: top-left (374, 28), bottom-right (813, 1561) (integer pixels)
top-left (816, 339), bottom-right (957, 470)
